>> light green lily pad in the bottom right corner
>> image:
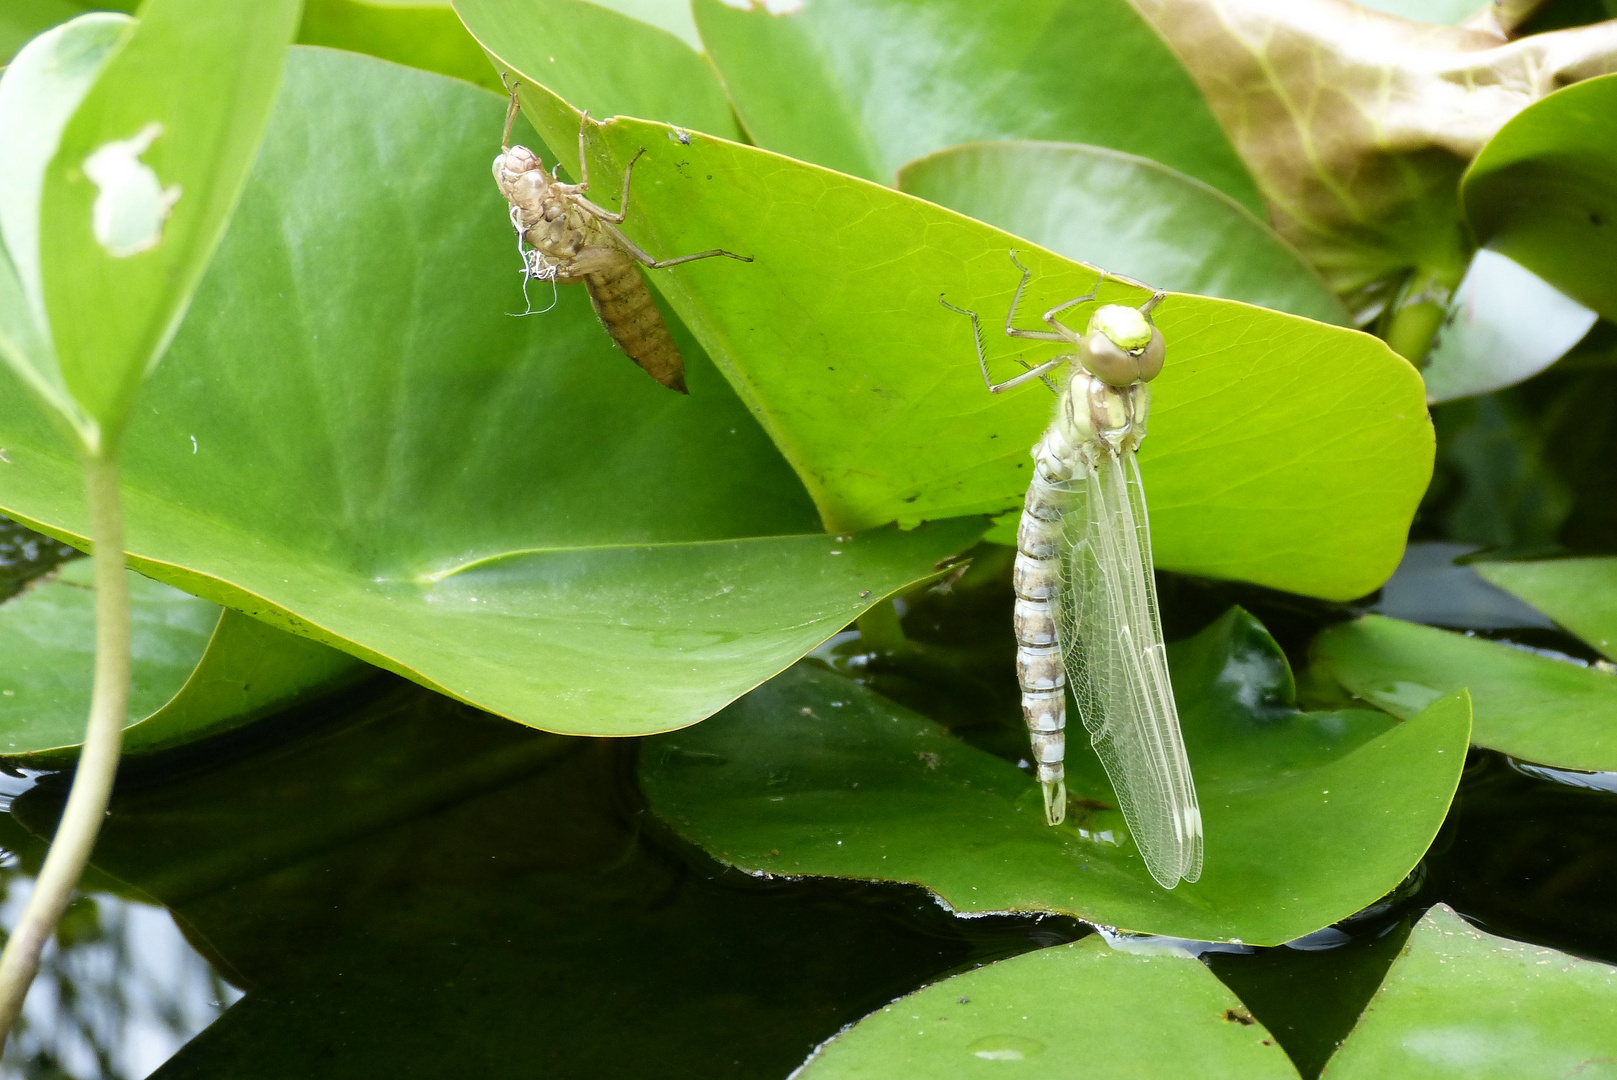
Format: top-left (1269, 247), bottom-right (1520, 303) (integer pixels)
top-left (1323, 904), bottom-right (1617, 1080)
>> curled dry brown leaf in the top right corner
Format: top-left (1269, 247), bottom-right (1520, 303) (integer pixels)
top-left (1134, 0), bottom-right (1617, 320)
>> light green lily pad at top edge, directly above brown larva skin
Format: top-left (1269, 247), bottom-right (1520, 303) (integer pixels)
top-left (454, 0), bottom-right (741, 147)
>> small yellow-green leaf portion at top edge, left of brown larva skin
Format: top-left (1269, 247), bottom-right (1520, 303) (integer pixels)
top-left (298, 0), bottom-right (503, 92)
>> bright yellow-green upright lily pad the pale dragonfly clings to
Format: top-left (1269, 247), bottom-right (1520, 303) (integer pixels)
top-left (465, 67), bottom-right (1433, 598)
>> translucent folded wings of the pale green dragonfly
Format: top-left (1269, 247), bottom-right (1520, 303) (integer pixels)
top-left (1056, 453), bottom-right (1201, 889)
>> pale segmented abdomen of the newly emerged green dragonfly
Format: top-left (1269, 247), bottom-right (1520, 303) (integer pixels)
top-left (1014, 427), bottom-right (1072, 820)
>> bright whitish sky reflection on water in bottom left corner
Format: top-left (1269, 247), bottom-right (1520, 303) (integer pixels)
top-left (0, 873), bottom-right (241, 1080)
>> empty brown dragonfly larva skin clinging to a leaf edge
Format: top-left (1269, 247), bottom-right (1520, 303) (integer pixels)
top-left (495, 84), bottom-right (752, 393)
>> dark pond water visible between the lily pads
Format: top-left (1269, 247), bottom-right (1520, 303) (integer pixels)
top-left (0, 472), bottom-right (1617, 1080)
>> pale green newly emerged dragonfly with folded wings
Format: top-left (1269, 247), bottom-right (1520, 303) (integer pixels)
top-left (938, 251), bottom-right (1201, 889)
